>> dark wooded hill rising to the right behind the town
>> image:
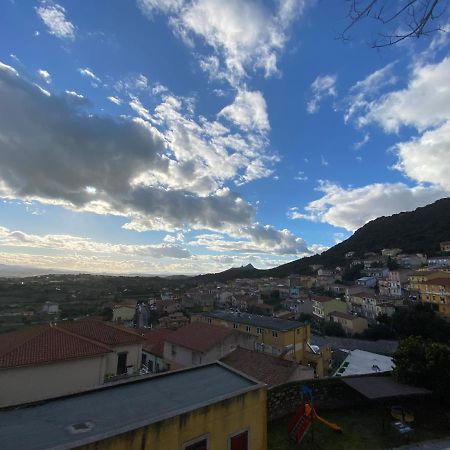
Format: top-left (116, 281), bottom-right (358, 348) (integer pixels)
top-left (196, 198), bottom-right (450, 281)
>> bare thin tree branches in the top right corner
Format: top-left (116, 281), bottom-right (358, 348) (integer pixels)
top-left (340, 0), bottom-right (448, 48)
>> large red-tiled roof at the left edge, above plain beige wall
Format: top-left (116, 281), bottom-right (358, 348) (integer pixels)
top-left (0, 325), bottom-right (112, 369)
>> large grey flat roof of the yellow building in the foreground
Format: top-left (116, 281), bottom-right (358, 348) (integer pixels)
top-left (0, 363), bottom-right (264, 450)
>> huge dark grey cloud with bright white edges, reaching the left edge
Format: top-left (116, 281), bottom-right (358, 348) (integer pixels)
top-left (0, 59), bottom-right (304, 254)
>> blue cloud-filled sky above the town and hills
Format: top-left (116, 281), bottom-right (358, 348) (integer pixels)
top-left (0, 0), bottom-right (450, 274)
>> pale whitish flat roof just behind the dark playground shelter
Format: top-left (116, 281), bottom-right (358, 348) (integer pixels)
top-left (333, 350), bottom-right (395, 377)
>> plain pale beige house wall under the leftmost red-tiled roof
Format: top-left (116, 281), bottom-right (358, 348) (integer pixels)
top-left (0, 355), bottom-right (106, 407)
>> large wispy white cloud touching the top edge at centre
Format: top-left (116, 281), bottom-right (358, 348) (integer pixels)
top-left (137, 0), bottom-right (307, 85)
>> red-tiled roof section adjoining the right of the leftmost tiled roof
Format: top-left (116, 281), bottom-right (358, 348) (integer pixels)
top-left (58, 319), bottom-right (143, 346)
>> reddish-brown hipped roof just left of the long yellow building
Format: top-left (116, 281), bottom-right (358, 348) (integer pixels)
top-left (166, 322), bottom-right (236, 352)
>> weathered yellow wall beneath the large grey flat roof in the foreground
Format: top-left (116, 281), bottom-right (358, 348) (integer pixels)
top-left (80, 388), bottom-right (267, 450)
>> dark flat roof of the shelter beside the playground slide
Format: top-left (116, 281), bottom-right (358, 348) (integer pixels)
top-left (342, 377), bottom-right (431, 400)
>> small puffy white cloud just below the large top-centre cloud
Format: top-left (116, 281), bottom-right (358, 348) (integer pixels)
top-left (218, 90), bottom-right (270, 132)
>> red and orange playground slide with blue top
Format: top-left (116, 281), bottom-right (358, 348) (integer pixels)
top-left (288, 386), bottom-right (342, 444)
